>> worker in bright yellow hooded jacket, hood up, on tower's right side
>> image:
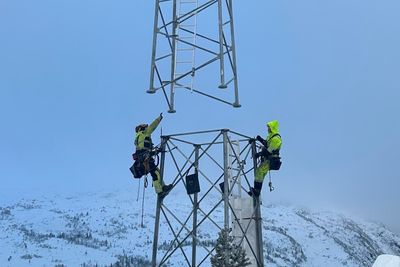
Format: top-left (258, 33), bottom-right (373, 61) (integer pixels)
top-left (248, 120), bottom-right (282, 197)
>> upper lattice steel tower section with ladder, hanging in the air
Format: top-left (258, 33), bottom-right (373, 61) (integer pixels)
top-left (147, 0), bottom-right (240, 113)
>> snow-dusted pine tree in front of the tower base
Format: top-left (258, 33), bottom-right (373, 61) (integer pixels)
top-left (211, 229), bottom-right (250, 267)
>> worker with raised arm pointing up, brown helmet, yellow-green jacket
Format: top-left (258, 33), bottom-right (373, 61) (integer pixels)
top-left (135, 113), bottom-right (173, 197)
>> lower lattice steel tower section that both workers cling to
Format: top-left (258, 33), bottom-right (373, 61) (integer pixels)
top-left (152, 129), bottom-right (264, 267)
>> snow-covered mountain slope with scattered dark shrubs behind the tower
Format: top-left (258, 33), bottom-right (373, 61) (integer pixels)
top-left (0, 189), bottom-right (400, 267)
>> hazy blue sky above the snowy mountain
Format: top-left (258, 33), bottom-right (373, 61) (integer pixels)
top-left (0, 0), bottom-right (400, 233)
